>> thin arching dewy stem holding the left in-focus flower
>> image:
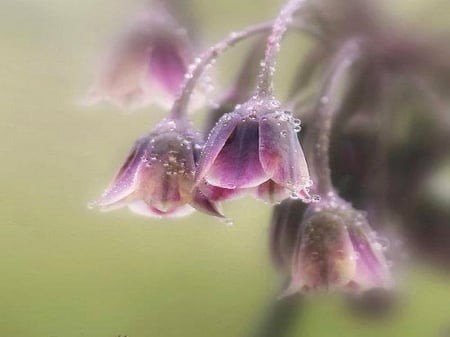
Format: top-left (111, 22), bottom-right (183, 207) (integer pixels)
top-left (171, 22), bottom-right (272, 118)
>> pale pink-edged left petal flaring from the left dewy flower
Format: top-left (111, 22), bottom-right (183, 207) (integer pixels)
top-left (96, 137), bottom-right (149, 207)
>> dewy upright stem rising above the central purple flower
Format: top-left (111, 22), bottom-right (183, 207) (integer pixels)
top-left (258, 0), bottom-right (303, 96)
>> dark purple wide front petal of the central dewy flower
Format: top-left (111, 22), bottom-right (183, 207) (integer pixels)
top-left (205, 120), bottom-right (268, 189)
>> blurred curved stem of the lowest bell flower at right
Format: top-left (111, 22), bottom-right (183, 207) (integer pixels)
top-left (311, 40), bottom-right (359, 195)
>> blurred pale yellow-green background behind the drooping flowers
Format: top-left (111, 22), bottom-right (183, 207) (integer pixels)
top-left (0, 0), bottom-right (450, 337)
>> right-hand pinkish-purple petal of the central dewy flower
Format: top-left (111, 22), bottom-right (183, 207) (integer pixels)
top-left (259, 113), bottom-right (310, 194)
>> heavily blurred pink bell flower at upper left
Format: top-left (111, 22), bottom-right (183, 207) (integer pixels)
top-left (85, 10), bottom-right (193, 108)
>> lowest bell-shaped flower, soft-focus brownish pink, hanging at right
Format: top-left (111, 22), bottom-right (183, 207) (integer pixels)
top-left (285, 197), bottom-right (393, 295)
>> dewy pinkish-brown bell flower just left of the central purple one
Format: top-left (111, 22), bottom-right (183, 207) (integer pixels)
top-left (92, 119), bottom-right (222, 217)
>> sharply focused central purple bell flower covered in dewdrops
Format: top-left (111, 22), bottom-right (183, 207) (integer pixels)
top-left (196, 97), bottom-right (311, 201)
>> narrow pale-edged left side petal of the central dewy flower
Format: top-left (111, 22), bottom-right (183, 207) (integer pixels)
top-left (195, 112), bottom-right (241, 184)
